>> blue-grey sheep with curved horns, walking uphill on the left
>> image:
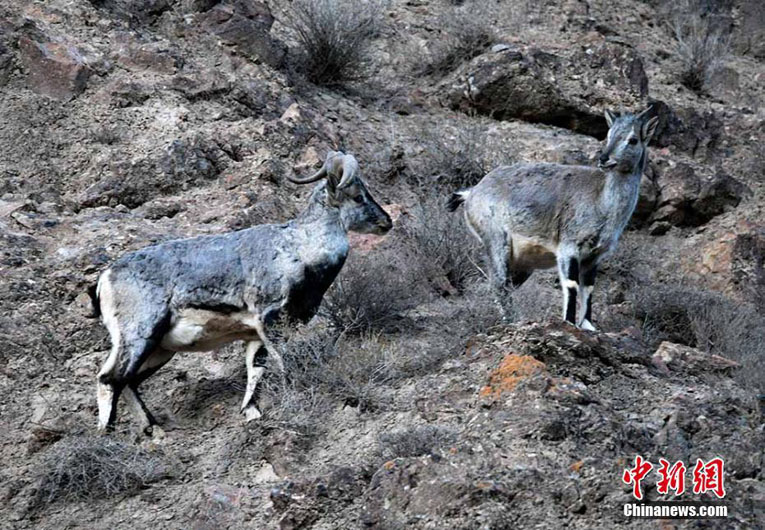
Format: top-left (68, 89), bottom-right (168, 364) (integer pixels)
top-left (97, 152), bottom-right (392, 428)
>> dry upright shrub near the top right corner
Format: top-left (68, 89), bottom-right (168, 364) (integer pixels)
top-left (672, 0), bottom-right (730, 92)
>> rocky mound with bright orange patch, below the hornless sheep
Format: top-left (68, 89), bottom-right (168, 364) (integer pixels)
top-left (271, 322), bottom-right (765, 528)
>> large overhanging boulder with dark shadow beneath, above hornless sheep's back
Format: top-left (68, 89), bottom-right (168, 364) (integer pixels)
top-left (438, 42), bottom-right (648, 138)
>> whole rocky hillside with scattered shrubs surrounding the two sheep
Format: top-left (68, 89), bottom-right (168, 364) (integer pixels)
top-left (0, 0), bottom-right (765, 529)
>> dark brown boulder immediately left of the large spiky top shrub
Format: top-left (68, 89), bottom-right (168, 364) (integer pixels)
top-left (202, 0), bottom-right (285, 67)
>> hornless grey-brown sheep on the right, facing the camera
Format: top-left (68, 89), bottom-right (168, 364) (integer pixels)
top-left (448, 107), bottom-right (658, 329)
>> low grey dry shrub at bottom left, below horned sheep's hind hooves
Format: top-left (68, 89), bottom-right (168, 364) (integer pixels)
top-left (35, 436), bottom-right (171, 508)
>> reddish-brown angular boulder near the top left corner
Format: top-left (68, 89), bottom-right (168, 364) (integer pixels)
top-left (19, 35), bottom-right (91, 101)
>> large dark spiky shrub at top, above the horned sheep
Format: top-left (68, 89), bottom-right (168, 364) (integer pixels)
top-left (284, 0), bottom-right (385, 85)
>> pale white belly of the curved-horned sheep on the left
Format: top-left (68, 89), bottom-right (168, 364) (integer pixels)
top-left (161, 309), bottom-right (258, 351)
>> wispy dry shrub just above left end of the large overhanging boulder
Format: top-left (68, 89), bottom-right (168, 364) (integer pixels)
top-left (422, 0), bottom-right (497, 75)
